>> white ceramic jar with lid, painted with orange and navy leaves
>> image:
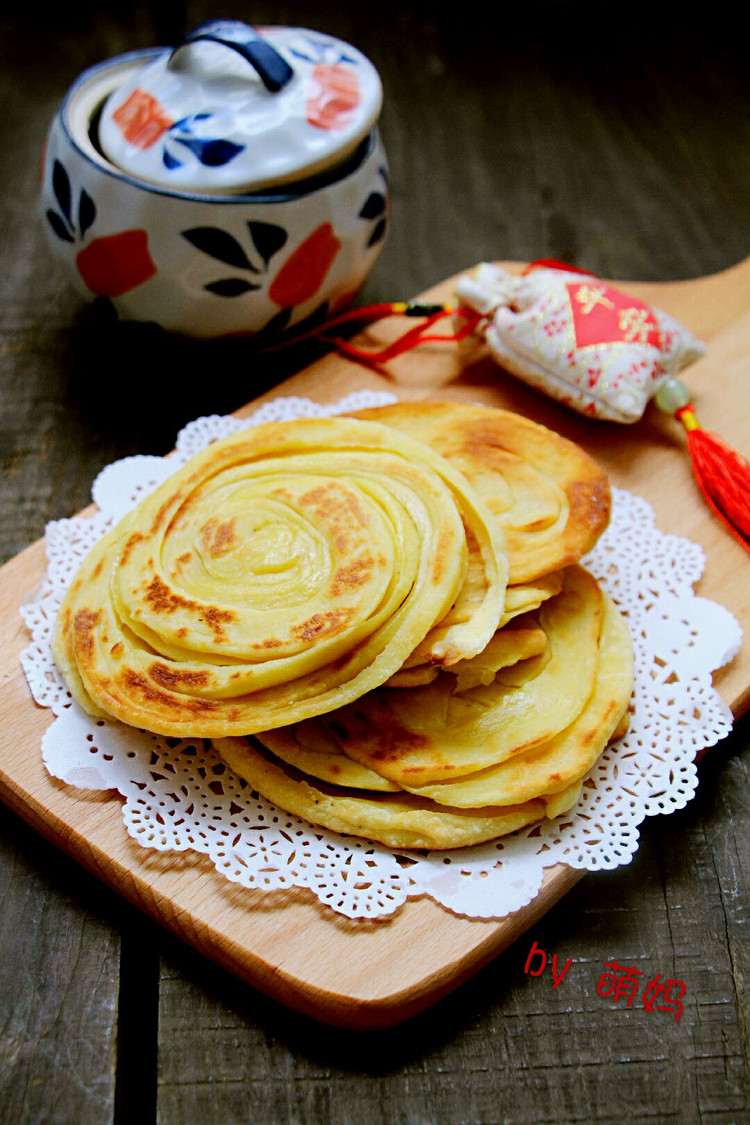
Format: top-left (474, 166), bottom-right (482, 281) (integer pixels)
top-left (42, 21), bottom-right (389, 338)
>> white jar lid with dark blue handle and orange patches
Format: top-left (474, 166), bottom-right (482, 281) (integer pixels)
top-left (99, 20), bottom-right (382, 194)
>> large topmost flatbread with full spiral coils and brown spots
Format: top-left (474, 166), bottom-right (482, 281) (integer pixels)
top-left (53, 419), bottom-right (507, 738)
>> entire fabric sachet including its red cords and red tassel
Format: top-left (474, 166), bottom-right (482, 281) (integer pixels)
top-left (266, 259), bottom-right (750, 552)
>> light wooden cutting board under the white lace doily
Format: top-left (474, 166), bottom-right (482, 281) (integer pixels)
top-left (0, 259), bottom-right (750, 1028)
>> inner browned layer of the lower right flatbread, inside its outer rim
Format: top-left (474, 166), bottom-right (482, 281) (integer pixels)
top-left (320, 566), bottom-right (604, 789)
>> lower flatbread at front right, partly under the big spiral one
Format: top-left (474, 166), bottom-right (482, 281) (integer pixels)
top-left (216, 567), bottom-right (633, 848)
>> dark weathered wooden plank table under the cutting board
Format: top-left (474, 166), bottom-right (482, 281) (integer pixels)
top-left (0, 0), bottom-right (750, 1125)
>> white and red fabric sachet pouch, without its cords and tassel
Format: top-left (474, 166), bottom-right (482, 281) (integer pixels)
top-left (457, 262), bottom-right (705, 422)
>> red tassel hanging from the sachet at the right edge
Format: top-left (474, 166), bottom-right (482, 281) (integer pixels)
top-left (675, 403), bottom-right (750, 552)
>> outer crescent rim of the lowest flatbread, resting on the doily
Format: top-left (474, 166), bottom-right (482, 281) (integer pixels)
top-left (216, 576), bottom-right (633, 848)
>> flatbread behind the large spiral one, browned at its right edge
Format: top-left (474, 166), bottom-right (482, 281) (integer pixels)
top-left (354, 403), bottom-right (611, 584)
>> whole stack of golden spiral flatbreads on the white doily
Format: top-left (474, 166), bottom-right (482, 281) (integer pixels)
top-left (53, 403), bottom-right (633, 848)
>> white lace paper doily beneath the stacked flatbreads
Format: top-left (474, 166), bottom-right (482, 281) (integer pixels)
top-left (21, 392), bottom-right (741, 919)
